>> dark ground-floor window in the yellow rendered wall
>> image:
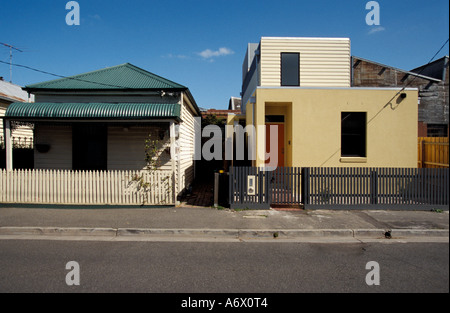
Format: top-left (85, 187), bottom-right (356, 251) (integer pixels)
top-left (341, 112), bottom-right (367, 157)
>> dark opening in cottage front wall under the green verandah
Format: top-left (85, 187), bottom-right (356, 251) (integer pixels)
top-left (72, 124), bottom-right (107, 171)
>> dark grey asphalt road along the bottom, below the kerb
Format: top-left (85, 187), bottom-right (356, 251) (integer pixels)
top-left (0, 240), bottom-right (449, 293)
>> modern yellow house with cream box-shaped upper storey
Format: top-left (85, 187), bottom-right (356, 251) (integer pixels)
top-left (227, 37), bottom-right (418, 167)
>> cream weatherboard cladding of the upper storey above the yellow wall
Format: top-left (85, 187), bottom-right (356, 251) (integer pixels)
top-left (260, 37), bottom-right (351, 87)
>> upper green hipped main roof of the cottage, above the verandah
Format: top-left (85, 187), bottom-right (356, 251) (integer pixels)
top-left (24, 63), bottom-right (187, 91)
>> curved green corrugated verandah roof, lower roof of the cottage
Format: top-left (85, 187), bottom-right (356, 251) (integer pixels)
top-left (5, 102), bottom-right (180, 120)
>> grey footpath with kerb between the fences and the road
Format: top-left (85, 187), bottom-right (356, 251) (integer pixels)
top-left (0, 204), bottom-right (449, 242)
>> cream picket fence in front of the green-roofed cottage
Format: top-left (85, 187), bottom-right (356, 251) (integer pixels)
top-left (0, 170), bottom-right (174, 205)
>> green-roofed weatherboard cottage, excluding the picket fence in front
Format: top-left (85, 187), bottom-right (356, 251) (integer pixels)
top-left (4, 63), bottom-right (200, 205)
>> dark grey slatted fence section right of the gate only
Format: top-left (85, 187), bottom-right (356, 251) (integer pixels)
top-left (303, 168), bottom-right (449, 210)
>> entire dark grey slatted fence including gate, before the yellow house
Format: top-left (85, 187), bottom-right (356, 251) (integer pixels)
top-left (229, 167), bottom-right (449, 210)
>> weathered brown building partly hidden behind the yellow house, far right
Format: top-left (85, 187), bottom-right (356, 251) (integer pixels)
top-left (352, 56), bottom-right (449, 137)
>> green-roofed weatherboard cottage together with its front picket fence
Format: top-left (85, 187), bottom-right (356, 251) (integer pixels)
top-left (0, 63), bottom-right (200, 204)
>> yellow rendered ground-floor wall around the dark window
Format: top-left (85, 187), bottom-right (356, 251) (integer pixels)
top-left (253, 88), bottom-right (418, 167)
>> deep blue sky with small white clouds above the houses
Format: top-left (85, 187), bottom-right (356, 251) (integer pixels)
top-left (0, 0), bottom-right (449, 109)
